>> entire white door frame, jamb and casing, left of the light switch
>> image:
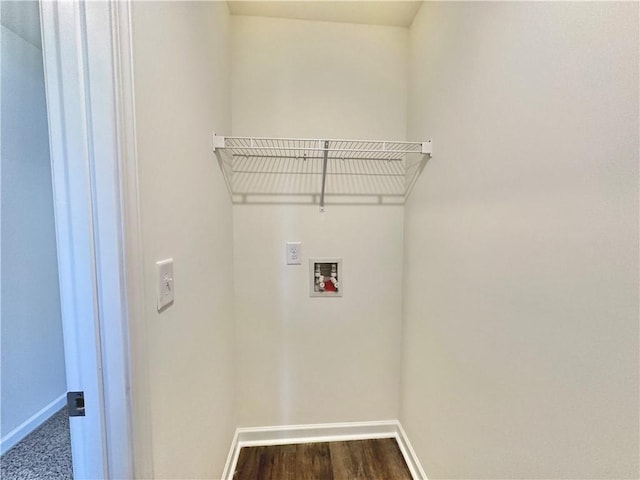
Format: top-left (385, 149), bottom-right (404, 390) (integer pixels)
top-left (40, 0), bottom-right (153, 479)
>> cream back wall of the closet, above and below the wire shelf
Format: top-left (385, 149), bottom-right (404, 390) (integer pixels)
top-left (232, 17), bottom-right (408, 426)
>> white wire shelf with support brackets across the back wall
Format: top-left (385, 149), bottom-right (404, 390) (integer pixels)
top-left (213, 134), bottom-right (432, 211)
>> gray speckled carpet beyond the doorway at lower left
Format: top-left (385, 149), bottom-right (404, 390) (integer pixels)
top-left (0, 408), bottom-right (73, 480)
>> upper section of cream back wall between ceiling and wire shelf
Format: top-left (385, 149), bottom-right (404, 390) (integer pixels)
top-left (232, 16), bottom-right (408, 140)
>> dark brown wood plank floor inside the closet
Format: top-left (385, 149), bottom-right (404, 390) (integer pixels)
top-left (233, 438), bottom-right (411, 480)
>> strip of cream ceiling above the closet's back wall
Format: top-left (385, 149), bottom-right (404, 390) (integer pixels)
top-left (227, 0), bottom-right (422, 27)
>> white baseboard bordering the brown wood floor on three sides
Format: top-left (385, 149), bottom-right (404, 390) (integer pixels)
top-left (222, 420), bottom-right (428, 480)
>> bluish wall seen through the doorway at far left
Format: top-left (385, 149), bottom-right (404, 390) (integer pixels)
top-left (0, 8), bottom-right (66, 452)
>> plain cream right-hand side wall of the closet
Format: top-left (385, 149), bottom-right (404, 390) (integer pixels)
top-left (402, 2), bottom-right (639, 479)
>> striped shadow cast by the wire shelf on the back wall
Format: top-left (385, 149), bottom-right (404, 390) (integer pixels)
top-left (218, 140), bottom-right (426, 206)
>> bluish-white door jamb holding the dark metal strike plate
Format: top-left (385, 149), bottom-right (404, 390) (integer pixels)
top-left (40, 2), bottom-right (109, 478)
